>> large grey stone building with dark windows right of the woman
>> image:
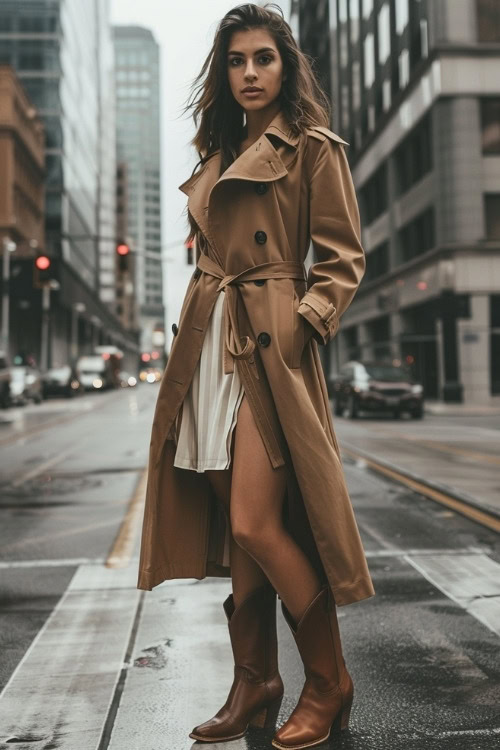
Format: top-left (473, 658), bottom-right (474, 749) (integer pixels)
top-left (295, 0), bottom-right (500, 403)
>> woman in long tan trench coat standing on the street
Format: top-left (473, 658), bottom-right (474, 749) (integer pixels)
top-left (138, 4), bottom-right (374, 749)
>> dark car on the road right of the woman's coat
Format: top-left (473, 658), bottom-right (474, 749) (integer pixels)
top-left (333, 361), bottom-right (424, 419)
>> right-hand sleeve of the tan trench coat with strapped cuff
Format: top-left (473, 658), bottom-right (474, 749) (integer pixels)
top-left (298, 137), bottom-right (365, 344)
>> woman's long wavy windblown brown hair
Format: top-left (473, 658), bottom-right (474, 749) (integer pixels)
top-left (184, 3), bottom-right (330, 238)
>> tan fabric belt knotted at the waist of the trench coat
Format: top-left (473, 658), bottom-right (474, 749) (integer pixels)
top-left (197, 253), bottom-right (307, 374)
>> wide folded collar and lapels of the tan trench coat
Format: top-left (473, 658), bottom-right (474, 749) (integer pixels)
top-left (179, 110), bottom-right (300, 195)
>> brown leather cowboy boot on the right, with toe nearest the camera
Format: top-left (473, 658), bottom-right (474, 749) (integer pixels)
top-left (272, 586), bottom-right (353, 750)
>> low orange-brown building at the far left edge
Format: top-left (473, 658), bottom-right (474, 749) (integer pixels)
top-left (0, 65), bottom-right (45, 358)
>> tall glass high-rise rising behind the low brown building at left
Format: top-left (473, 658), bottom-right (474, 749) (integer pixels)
top-left (0, 0), bottom-right (138, 364)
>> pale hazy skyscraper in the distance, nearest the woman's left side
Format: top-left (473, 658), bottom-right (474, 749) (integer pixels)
top-left (114, 26), bottom-right (164, 351)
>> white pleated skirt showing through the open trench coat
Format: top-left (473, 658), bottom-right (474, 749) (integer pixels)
top-left (174, 289), bottom-right (244, 472)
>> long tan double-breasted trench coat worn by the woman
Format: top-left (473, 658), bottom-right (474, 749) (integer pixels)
top-left (138, 108), bottom-right (374, 606)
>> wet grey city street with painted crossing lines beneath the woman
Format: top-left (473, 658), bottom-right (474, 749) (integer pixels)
top-left (0, 384), bottom-right (500, 750)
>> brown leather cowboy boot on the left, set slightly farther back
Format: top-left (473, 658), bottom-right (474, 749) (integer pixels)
top-left (189, 583), bottom-right (283, 742)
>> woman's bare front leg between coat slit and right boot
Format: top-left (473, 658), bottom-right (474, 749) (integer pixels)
top-left (230, 396), bottom-right (321, 622)
